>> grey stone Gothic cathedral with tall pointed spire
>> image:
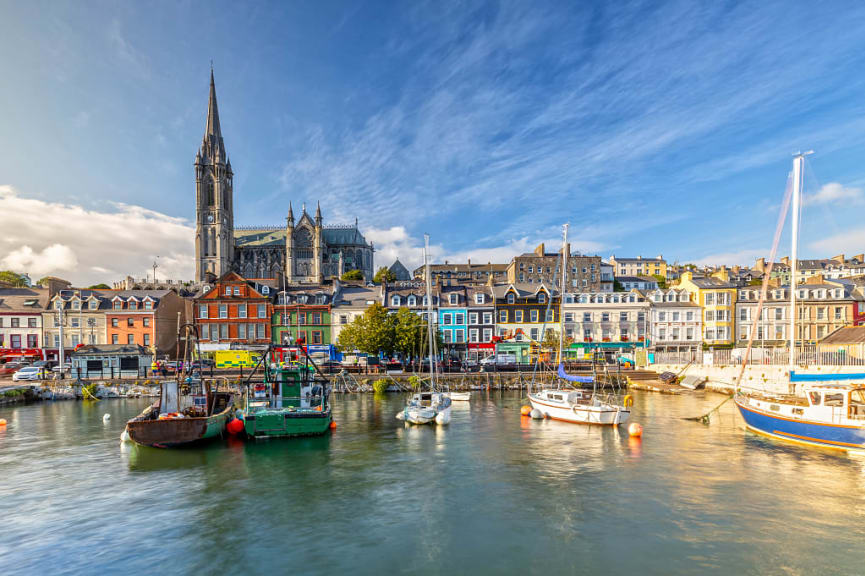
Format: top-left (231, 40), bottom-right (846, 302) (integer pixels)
top-left (195, 70), bottom-right (373, 284)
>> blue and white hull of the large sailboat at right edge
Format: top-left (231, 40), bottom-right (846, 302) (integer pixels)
top-left (735, 397), bottom-right (865, 452)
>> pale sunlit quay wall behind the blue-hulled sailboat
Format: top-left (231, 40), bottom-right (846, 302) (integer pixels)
top-left (648, 364), bottom-right (859, 395)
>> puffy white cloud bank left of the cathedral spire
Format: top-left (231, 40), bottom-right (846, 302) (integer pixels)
top-left (0, 185), bottom-right (194, 285)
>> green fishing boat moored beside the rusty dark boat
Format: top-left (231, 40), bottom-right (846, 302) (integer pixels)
top-left (243, 347), bottom-right (333, 438)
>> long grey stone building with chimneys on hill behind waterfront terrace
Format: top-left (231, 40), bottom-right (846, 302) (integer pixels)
top-left (507, 244), bottom-right (601, 292)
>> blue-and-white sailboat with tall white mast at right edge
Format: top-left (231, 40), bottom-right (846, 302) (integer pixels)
top-left (734, 152), bottom-right (865, 452)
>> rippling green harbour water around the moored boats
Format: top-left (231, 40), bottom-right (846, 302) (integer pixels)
top-left (0, 392), bottom-right (865, 575)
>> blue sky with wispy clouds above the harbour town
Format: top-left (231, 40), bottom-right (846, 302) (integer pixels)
top-left (0, 0), bottom-right (865, 283)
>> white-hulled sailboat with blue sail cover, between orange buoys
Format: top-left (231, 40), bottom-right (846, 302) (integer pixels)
top-left (529, 224), bottom-right (631, 426)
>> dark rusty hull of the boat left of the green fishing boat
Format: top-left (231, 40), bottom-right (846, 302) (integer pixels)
top-left (126, 403), bottom-right (234, 448)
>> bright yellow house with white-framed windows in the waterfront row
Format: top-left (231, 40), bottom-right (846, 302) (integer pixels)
top-left (678, 268), bottom-right (736, 346)
